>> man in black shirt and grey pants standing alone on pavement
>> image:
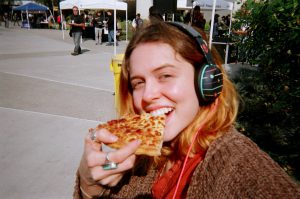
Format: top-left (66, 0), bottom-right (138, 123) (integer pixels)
top-left (70, 6), bottom-right (85, 55)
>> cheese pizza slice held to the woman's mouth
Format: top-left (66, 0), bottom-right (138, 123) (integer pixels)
top-left (90, 113), bottom-right (166, 156)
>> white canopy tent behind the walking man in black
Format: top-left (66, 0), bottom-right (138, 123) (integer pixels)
top-left (59, 0), bottom-right (128, 54)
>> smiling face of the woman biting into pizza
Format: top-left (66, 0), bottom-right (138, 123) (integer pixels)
top-left (130, 42), bottom-right (199, 142)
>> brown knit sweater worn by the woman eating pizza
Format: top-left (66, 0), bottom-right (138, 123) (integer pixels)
top-left (73, 129), bottom-right (300, 199)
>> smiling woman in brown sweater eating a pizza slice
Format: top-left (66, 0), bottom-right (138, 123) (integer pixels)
top-left (74, 22), bottom-right (300, 198)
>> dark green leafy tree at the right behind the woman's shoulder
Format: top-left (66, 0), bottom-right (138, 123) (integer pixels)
top-left (233, 0), bottom-right (300, 180)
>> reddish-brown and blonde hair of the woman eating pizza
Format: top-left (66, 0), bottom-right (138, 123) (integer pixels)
top-left (118, 22), bottom-right (239, 165)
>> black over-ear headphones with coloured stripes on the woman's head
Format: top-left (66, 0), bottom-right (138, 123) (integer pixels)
top-left (166, 22), bottom-right (223, 104)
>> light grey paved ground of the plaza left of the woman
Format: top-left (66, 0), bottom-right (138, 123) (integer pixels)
top-left (0, 26), bottom-right (127, 199)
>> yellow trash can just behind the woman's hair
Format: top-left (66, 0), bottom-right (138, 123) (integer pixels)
top-left (110, 54), bottom-right (124, 110)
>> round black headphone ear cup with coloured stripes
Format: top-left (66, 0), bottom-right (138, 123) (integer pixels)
top-left (195, 64), bottom-right (223, 104)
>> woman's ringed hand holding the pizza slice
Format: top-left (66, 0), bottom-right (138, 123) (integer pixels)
top-left (79, 129), bottom-right (140, 192)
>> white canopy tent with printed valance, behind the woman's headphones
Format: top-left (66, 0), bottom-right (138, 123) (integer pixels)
top-left (177, 0), bottom-right (236, 64)
